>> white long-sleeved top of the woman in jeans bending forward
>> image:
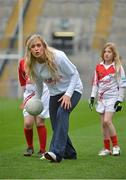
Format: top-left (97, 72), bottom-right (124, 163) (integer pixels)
top-left (35, 50), bottom-right (83, 97)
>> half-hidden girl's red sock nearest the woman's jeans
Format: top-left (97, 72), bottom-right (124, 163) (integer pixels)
top-left (37, 125), bottom-right (47, 153)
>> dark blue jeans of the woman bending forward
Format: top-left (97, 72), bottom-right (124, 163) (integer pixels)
top-left (49, 91), bottom-right (81, 162)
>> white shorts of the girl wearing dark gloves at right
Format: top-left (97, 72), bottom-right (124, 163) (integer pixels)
top-left (96, 98), bottom-right (117, 113)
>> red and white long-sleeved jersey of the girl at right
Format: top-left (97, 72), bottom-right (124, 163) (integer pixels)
top-left (91, 62), bottom-right (126, 101)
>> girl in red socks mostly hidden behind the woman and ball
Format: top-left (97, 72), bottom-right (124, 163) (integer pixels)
top-left (18, 59), bottom-right (49, 158)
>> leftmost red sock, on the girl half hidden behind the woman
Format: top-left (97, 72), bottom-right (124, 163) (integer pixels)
top-left (24, 128), bottom-right (33, 148)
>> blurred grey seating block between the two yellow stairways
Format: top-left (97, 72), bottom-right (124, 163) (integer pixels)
top-left (38, 0), bottom-right (100, 49)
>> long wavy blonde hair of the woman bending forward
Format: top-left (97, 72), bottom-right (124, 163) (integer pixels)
top-left (25, 34), bottom-right (59, 80)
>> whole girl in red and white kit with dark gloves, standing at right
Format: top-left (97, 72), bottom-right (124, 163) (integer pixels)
top-left (89, 43), bottom-right (126, 156)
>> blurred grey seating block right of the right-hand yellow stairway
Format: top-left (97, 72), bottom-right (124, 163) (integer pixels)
top-left (108, 0), bottom-right (126, 59)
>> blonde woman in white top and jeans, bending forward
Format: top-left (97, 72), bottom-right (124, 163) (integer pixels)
top-left (25, 34), bottom-right (83, 162)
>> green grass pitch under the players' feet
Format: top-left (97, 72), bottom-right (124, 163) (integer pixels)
top-left (0, 99), bottom-right (126, 179)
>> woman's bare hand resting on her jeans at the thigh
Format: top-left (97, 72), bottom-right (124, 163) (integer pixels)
top-left (58, 95), bottom-right (71, 109)
